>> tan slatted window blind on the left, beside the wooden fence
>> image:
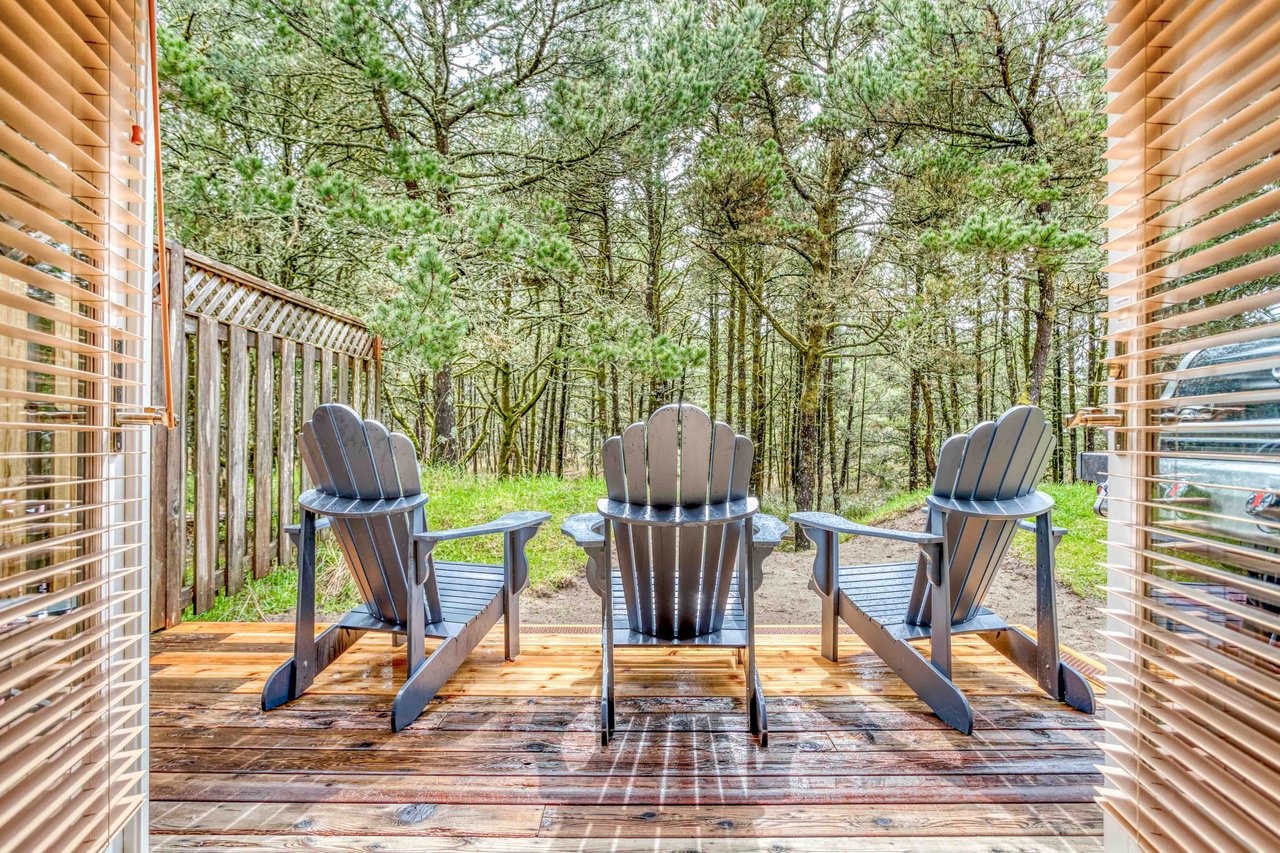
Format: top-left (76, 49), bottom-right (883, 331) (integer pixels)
top-left (0, 0), bottom-right (151, 850)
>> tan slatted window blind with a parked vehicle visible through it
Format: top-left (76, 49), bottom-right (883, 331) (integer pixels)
top-left (1101, 0), bottom-right (1280, 850)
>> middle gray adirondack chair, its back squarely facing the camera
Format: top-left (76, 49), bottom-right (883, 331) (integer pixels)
top-left (561, 403), bottom-right (786, 745)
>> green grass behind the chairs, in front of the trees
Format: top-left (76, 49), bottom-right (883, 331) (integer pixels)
top-left (183, 479), bottom-right (1106, 621)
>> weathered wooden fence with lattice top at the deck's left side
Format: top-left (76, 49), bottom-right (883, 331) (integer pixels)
top-left (151, 242), bottom-right (381, 630)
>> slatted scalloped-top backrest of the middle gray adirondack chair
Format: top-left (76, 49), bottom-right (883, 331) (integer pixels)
top-left (602, 403), bottom-right (755, 639)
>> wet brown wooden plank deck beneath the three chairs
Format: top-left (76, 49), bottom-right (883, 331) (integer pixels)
top-left (151, 622), bottom-right (1102, 853)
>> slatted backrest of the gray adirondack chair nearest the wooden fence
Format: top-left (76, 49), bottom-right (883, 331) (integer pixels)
top-left (298, 403), bottom-right (425, 622)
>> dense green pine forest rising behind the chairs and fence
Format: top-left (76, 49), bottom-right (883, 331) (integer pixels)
top-left (160, 0), bottom-right (1105, 510)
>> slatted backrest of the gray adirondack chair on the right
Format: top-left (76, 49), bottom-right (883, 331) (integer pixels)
top-left (906, 406), bottom-right (1053, 625)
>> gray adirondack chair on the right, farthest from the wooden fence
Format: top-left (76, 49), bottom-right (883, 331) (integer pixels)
top-left (791, 406), bottom-right (1094, 734)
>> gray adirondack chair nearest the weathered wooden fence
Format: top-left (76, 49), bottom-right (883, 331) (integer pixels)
top-left (262, 403), bottom-right (550, 731)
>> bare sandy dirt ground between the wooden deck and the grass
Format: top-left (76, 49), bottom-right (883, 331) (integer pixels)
top-left (521, 512), bottom-right (1103, 658)
